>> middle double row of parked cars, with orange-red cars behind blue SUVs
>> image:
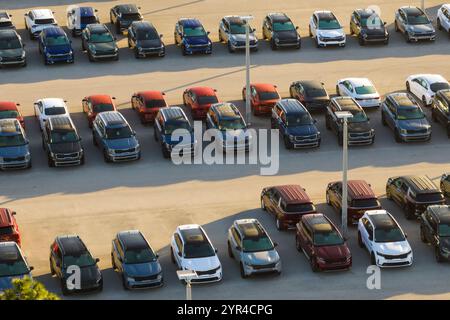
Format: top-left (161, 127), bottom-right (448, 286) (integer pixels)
top-left (0, 74), bottom-right (450, 169)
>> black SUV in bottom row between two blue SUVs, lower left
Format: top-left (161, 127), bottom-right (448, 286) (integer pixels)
top-left (50, 235), bottom-right (103, 295)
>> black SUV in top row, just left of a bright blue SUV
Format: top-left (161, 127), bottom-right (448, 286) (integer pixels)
top-left (128, 21), bottom-right (166, 59)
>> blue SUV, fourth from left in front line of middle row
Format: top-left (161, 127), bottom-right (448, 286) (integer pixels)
top-left (153, 107), bottom-right (197, 159)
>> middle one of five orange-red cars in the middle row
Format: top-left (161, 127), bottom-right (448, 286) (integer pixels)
top-left (131, 91), bottom-right (168, 124)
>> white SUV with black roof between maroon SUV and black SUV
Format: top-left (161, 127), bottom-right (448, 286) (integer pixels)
top-left (358, 210), bottom-right (413, 267)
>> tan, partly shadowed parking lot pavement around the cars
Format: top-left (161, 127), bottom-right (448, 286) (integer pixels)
top-left (0, 0), bottom-right (450, 299)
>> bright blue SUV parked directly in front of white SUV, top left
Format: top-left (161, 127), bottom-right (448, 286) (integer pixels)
top-left (39, 27), bottom-right (75, 64)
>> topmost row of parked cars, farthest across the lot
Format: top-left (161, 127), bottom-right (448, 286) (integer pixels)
top-left (0, 4), bottom-right (450, 66)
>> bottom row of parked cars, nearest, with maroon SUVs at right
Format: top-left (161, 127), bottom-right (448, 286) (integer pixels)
top-left (0, 174), bottom-right (450, 294)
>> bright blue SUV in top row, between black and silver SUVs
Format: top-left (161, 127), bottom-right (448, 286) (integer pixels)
top-left (174, 18), bottom-right (212, 55)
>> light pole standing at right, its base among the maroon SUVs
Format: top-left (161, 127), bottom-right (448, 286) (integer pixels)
top-left (335, 111), bottom-right (353, 237)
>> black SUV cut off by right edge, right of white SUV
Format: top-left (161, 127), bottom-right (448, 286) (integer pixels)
top-left (419, 205), bottom-right (450, 262)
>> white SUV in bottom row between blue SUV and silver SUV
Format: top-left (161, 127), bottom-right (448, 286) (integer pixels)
top-left (170, 224), bottom-right (222, 283)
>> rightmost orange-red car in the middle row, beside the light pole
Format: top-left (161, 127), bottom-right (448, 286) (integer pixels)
top-left (242, 83), bottom-right (281, 115)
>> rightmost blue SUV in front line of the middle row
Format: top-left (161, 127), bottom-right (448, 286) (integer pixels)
top-left (381, 92), bottom-right (431, 143)
